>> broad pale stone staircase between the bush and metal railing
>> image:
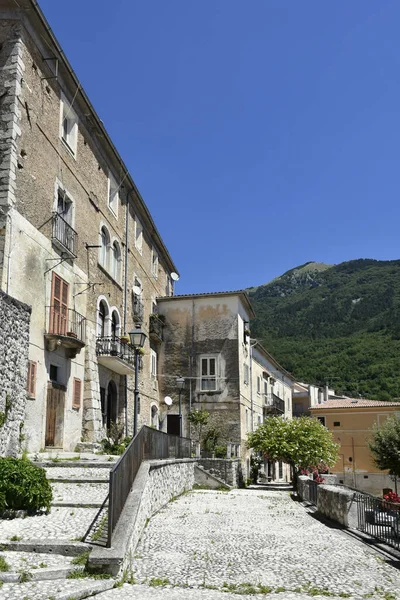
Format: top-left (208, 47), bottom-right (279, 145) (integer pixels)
top-left (0, 453), bottom-right (118, 600)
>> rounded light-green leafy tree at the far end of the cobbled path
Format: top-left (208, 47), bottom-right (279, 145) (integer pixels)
top-left (247, 417), bottom-right (339, 488)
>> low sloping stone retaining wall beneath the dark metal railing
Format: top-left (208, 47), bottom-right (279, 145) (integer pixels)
top-left (88, 458), bottom-right (196, 576)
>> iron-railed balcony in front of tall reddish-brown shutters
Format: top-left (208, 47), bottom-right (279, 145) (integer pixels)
top-left (44, 306), bottom-right (86, 358)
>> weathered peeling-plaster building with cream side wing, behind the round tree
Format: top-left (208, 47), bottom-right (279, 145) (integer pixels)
top-left (158, 291), bottom-right (292, 478)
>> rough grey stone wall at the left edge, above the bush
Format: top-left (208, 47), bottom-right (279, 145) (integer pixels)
top-left (0, 291), bottom-right (31, 456)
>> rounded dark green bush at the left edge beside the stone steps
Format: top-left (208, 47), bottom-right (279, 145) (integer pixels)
top-left (0, 458), bottom-right (53, 514)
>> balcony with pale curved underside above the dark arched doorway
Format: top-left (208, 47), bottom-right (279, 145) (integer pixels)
top-left (96, 337), bottom-right (135, 375)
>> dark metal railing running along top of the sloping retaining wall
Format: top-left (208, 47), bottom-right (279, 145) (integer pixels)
top-left (107, 425), bottom-right (191, 548)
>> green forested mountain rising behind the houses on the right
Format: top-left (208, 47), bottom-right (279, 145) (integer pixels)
top-left (248, 259), bottom-right (400, 400)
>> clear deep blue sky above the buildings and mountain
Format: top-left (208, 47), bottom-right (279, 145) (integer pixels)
top-left (40, 0), bottom-right (400, 293)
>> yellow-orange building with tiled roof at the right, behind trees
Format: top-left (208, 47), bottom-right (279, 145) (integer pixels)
top-left (310, 398), bottom-right (400, 495)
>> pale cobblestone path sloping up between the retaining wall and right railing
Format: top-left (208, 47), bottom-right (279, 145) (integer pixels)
top-left (97, 489), bottom-right (400, 600)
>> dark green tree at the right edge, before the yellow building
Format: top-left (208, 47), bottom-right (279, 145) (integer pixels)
top-left (368, 416), bottom-right (400, 477)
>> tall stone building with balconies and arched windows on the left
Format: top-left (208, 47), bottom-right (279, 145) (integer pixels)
top-left (0, 0), bottom-right (176, 451)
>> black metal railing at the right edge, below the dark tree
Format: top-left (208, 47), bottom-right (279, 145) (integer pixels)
top-left (355, 494), bottom-right (400, 550)
